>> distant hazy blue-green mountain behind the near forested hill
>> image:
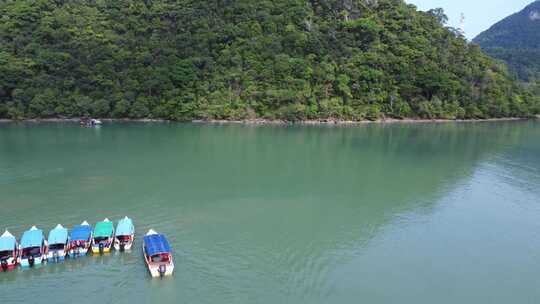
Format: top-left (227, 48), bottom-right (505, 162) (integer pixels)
top-left (473, 1), bottom-right (540, 81)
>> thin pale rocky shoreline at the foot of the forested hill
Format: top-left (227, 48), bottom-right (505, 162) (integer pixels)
top-left (0, 115), bottom-right (540, 125)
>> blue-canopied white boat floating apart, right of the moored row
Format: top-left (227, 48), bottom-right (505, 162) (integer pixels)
top-left (143, 229), bottom-right (174, 278)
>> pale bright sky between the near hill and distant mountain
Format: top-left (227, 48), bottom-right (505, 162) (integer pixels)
top-left (405, 0), bottom-right (534, 39)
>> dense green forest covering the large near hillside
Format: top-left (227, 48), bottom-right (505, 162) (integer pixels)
top-left (0, 0), bottom-right (539, 120)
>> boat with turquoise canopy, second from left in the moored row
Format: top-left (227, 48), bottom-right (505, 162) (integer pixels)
top-left (20, 226), bottom-right (47, 267)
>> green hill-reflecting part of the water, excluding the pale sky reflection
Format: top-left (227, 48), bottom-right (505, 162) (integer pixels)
top-left (0, 123), bottom-right (538, 303)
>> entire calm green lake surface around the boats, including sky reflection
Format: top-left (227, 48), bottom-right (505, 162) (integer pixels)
top-left (0, 122), bottom-right (540, 304)
